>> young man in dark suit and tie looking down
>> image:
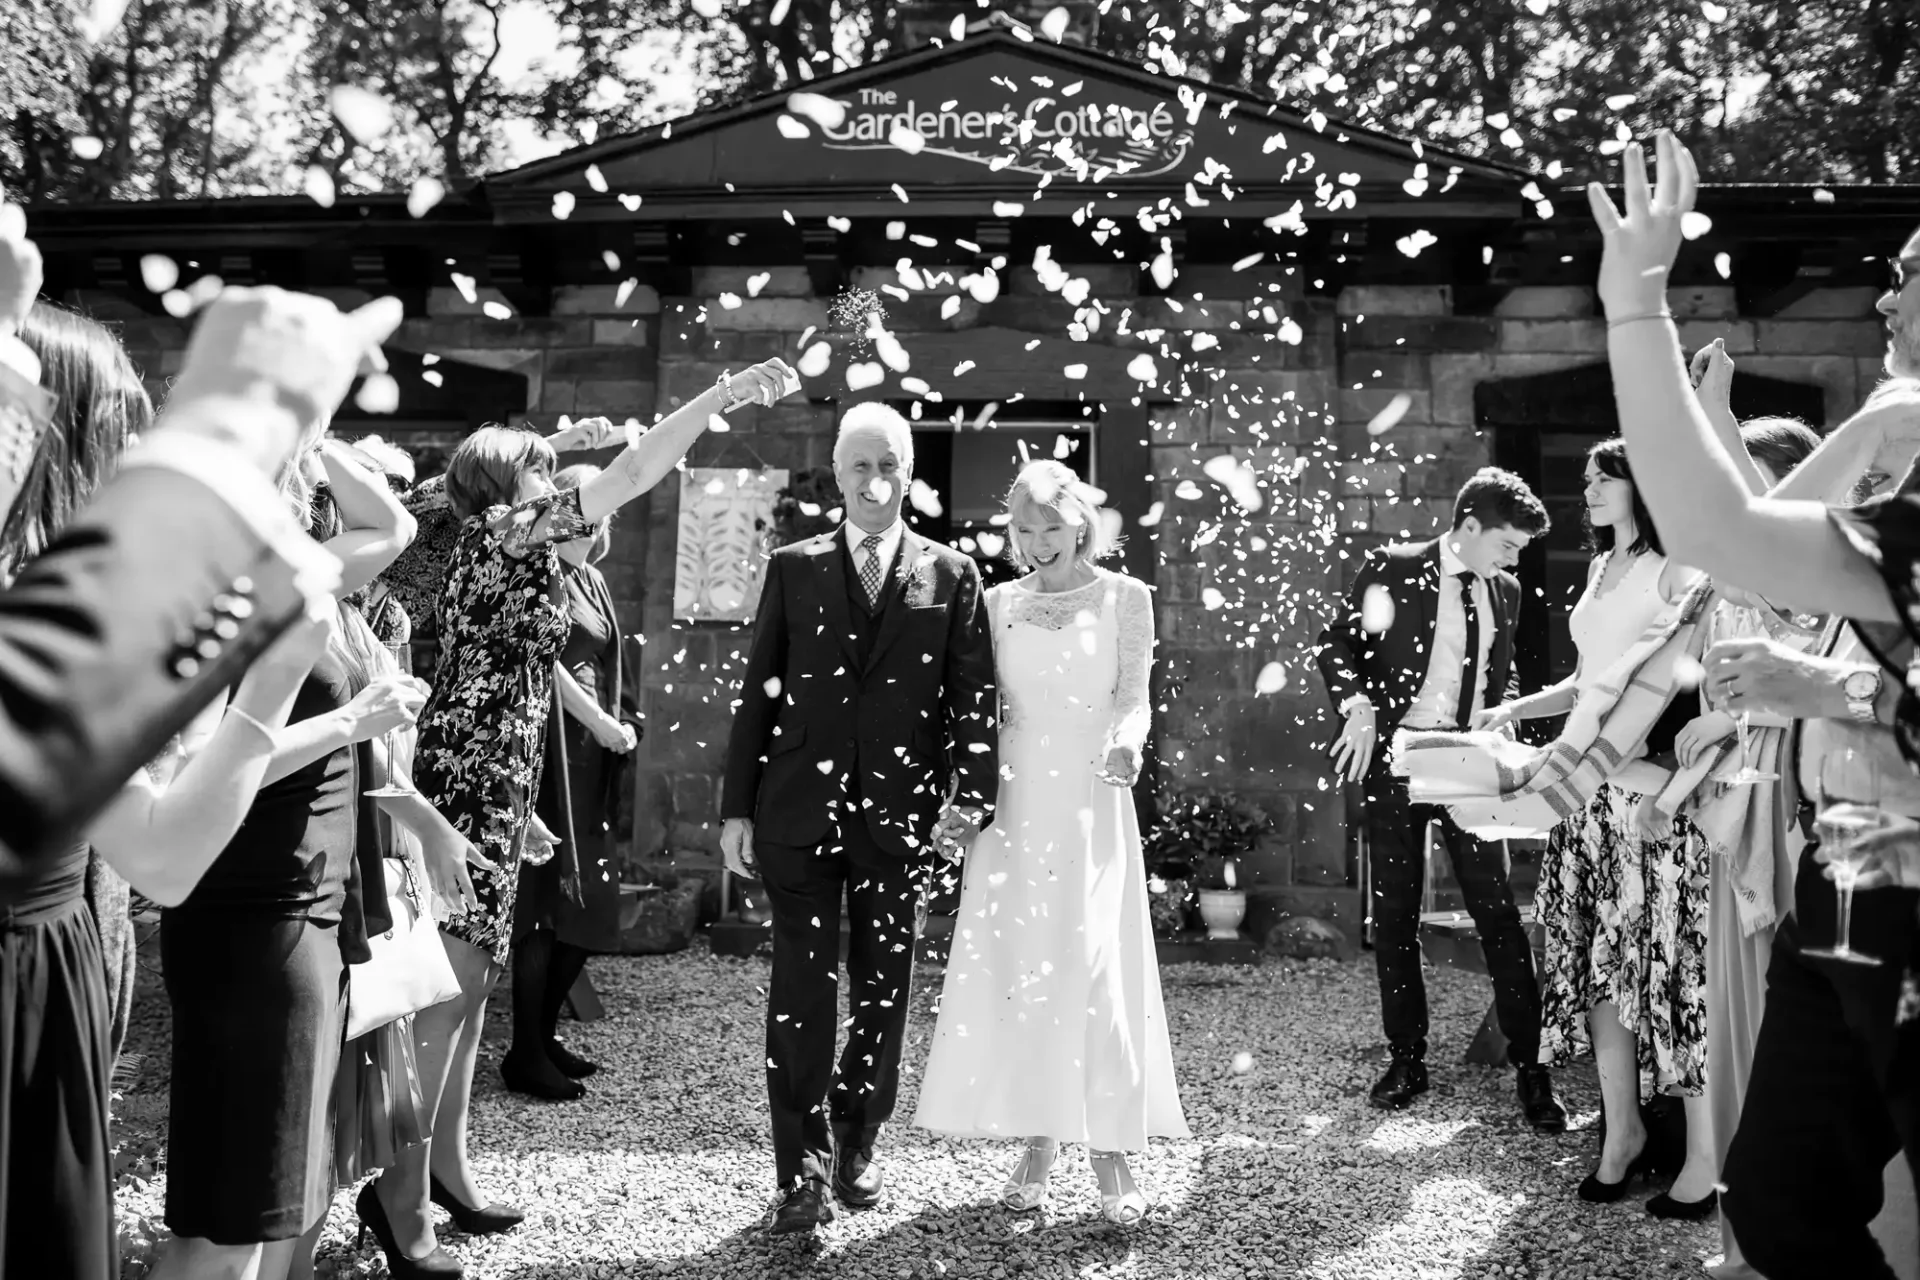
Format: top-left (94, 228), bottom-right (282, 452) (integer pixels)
top-left (1319, 466), bottom-right (1567, 1132)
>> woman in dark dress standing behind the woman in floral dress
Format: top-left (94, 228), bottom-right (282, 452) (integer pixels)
top-left (499, 466), bottom-right (637, 1102)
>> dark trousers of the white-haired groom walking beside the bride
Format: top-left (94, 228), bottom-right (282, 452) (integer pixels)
top-left (755, 821), bottom-right (924, 1188)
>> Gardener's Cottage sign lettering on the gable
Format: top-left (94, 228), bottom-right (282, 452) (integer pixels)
top-left (816, 77), bottom-right (1192, 182)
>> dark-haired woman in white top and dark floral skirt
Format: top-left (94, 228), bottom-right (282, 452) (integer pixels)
top-left (1478, 439), bottom-right (1718, 1219)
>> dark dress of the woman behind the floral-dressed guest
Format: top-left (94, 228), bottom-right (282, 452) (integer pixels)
top-left (515, 562), bottom-right (630, 954)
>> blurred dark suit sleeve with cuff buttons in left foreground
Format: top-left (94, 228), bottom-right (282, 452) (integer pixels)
top-left (0, 466), bottom-right (303, 904)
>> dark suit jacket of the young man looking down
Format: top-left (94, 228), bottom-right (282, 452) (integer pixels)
top-left (1315, 537), bottom-right (1521, 741)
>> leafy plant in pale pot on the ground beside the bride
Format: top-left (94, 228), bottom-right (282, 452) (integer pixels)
top-left (1146, 791), bottom-right (1273, 938)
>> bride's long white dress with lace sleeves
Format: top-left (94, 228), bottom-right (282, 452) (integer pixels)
top-left (914, 572), bottom-right (1188, 1151)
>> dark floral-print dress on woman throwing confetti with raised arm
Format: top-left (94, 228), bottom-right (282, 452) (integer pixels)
top-left (413, 489), bottom-right (593, 963)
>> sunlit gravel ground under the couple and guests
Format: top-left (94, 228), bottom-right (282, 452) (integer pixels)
top-left (119, 944), bottom-right (1718, 1280)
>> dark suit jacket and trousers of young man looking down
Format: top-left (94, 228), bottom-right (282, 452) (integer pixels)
top-left (1317, 539), bottom-right (1540, 1065)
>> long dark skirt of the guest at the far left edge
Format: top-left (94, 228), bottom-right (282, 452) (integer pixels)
top-left (0, 844), bottom-right (119, 1280)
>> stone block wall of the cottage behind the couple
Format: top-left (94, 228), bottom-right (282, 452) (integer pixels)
top-left (63, 263), bottom-right (1884, 925)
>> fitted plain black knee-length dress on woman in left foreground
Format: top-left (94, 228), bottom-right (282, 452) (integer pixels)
top-left (161, 654), bottom-right (386, 1245)
